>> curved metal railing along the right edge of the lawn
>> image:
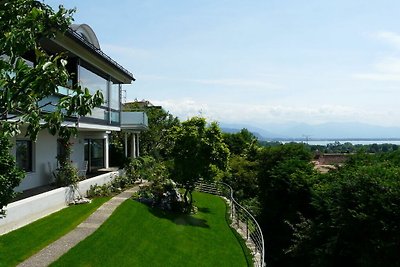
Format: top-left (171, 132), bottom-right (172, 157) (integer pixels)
top-left (196, 182), bottom-right (265, 267)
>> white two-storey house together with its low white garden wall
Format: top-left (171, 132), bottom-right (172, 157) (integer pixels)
top-left (0, 24), bottom-right (148, 235)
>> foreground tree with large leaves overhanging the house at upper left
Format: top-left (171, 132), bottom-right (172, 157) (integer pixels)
top-left (0, 0), bottom-right (103, 214)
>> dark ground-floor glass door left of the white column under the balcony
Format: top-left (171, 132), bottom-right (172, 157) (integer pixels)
top-left (85, 139), bottom-right (104, 172)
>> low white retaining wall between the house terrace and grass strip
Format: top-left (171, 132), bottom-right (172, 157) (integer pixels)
top-left (0, 171), bottom-right (119, 235)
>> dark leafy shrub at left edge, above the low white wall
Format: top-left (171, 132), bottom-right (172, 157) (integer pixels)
top-left (0, 134), bottom-right (25, 217)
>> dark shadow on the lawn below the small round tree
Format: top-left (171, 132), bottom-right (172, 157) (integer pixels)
top-left (147, 206), bottom-right (210, 228)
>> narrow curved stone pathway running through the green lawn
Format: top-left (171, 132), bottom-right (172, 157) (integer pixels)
top-left (18, 186), bottom-right (139, 267)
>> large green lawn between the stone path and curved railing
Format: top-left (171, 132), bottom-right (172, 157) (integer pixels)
top-left (52, 193), bottom-right (248, 266)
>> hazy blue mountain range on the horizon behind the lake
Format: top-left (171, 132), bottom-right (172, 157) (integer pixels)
top-left (220, 122), bottom-right (400, 140)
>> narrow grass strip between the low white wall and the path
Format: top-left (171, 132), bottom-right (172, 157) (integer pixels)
top-left (0, 198), bottom-right (109, 266)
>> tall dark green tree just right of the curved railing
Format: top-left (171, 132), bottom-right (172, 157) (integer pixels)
top-left (258, 144), bottom-right (314, 266)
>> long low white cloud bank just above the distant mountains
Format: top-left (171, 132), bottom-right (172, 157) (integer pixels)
top-left (153, 99), bottom-right (394, 125)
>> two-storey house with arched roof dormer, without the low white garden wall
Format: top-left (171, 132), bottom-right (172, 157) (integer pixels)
top-left (13, 24), bottom-right (148, 191)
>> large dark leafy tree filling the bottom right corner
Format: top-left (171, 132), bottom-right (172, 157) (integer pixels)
top-left (292, 162), bottom-right (400, 266)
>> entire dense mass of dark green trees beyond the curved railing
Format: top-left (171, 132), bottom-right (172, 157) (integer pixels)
top-left (224, 144), bottom-right (400, 266)
